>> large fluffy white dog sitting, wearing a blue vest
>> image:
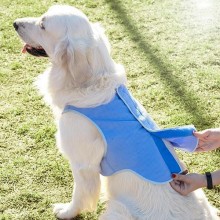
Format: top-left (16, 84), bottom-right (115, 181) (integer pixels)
top-left (14, 6), bottom-right (217, 220)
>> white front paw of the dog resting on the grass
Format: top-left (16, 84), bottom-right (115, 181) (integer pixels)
top-left (53, 203), bottom-right (78, 220)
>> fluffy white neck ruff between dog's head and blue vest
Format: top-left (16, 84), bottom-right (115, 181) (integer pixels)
top-left (36, 62), bottom-right (126, 114)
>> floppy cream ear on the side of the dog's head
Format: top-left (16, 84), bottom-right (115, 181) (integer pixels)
top-left (54, 37), bottom-right (92, 84)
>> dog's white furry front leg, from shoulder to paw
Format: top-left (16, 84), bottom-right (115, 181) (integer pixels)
top-left (54, 113), bottom-right (104, 219)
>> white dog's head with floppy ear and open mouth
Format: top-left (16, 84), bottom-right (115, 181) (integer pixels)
top-left (14, 5), bottom-right (115, 84)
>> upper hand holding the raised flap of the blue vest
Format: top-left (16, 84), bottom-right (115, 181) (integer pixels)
top-left (194, 128), bottom-right (220, 152)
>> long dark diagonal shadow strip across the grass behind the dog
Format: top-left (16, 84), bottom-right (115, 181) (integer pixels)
top-left (105, 0), bottom-right (213, 127)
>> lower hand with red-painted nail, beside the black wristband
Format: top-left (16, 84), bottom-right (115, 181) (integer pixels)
top-left (170, 173), bottom-right (207, 196)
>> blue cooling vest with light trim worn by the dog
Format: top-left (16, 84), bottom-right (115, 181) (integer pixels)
top-left (63, 85), bottom-right (198, 183)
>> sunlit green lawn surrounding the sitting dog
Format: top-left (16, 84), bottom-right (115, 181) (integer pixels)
top-left (0, 0), bottom-right (220, 220)
